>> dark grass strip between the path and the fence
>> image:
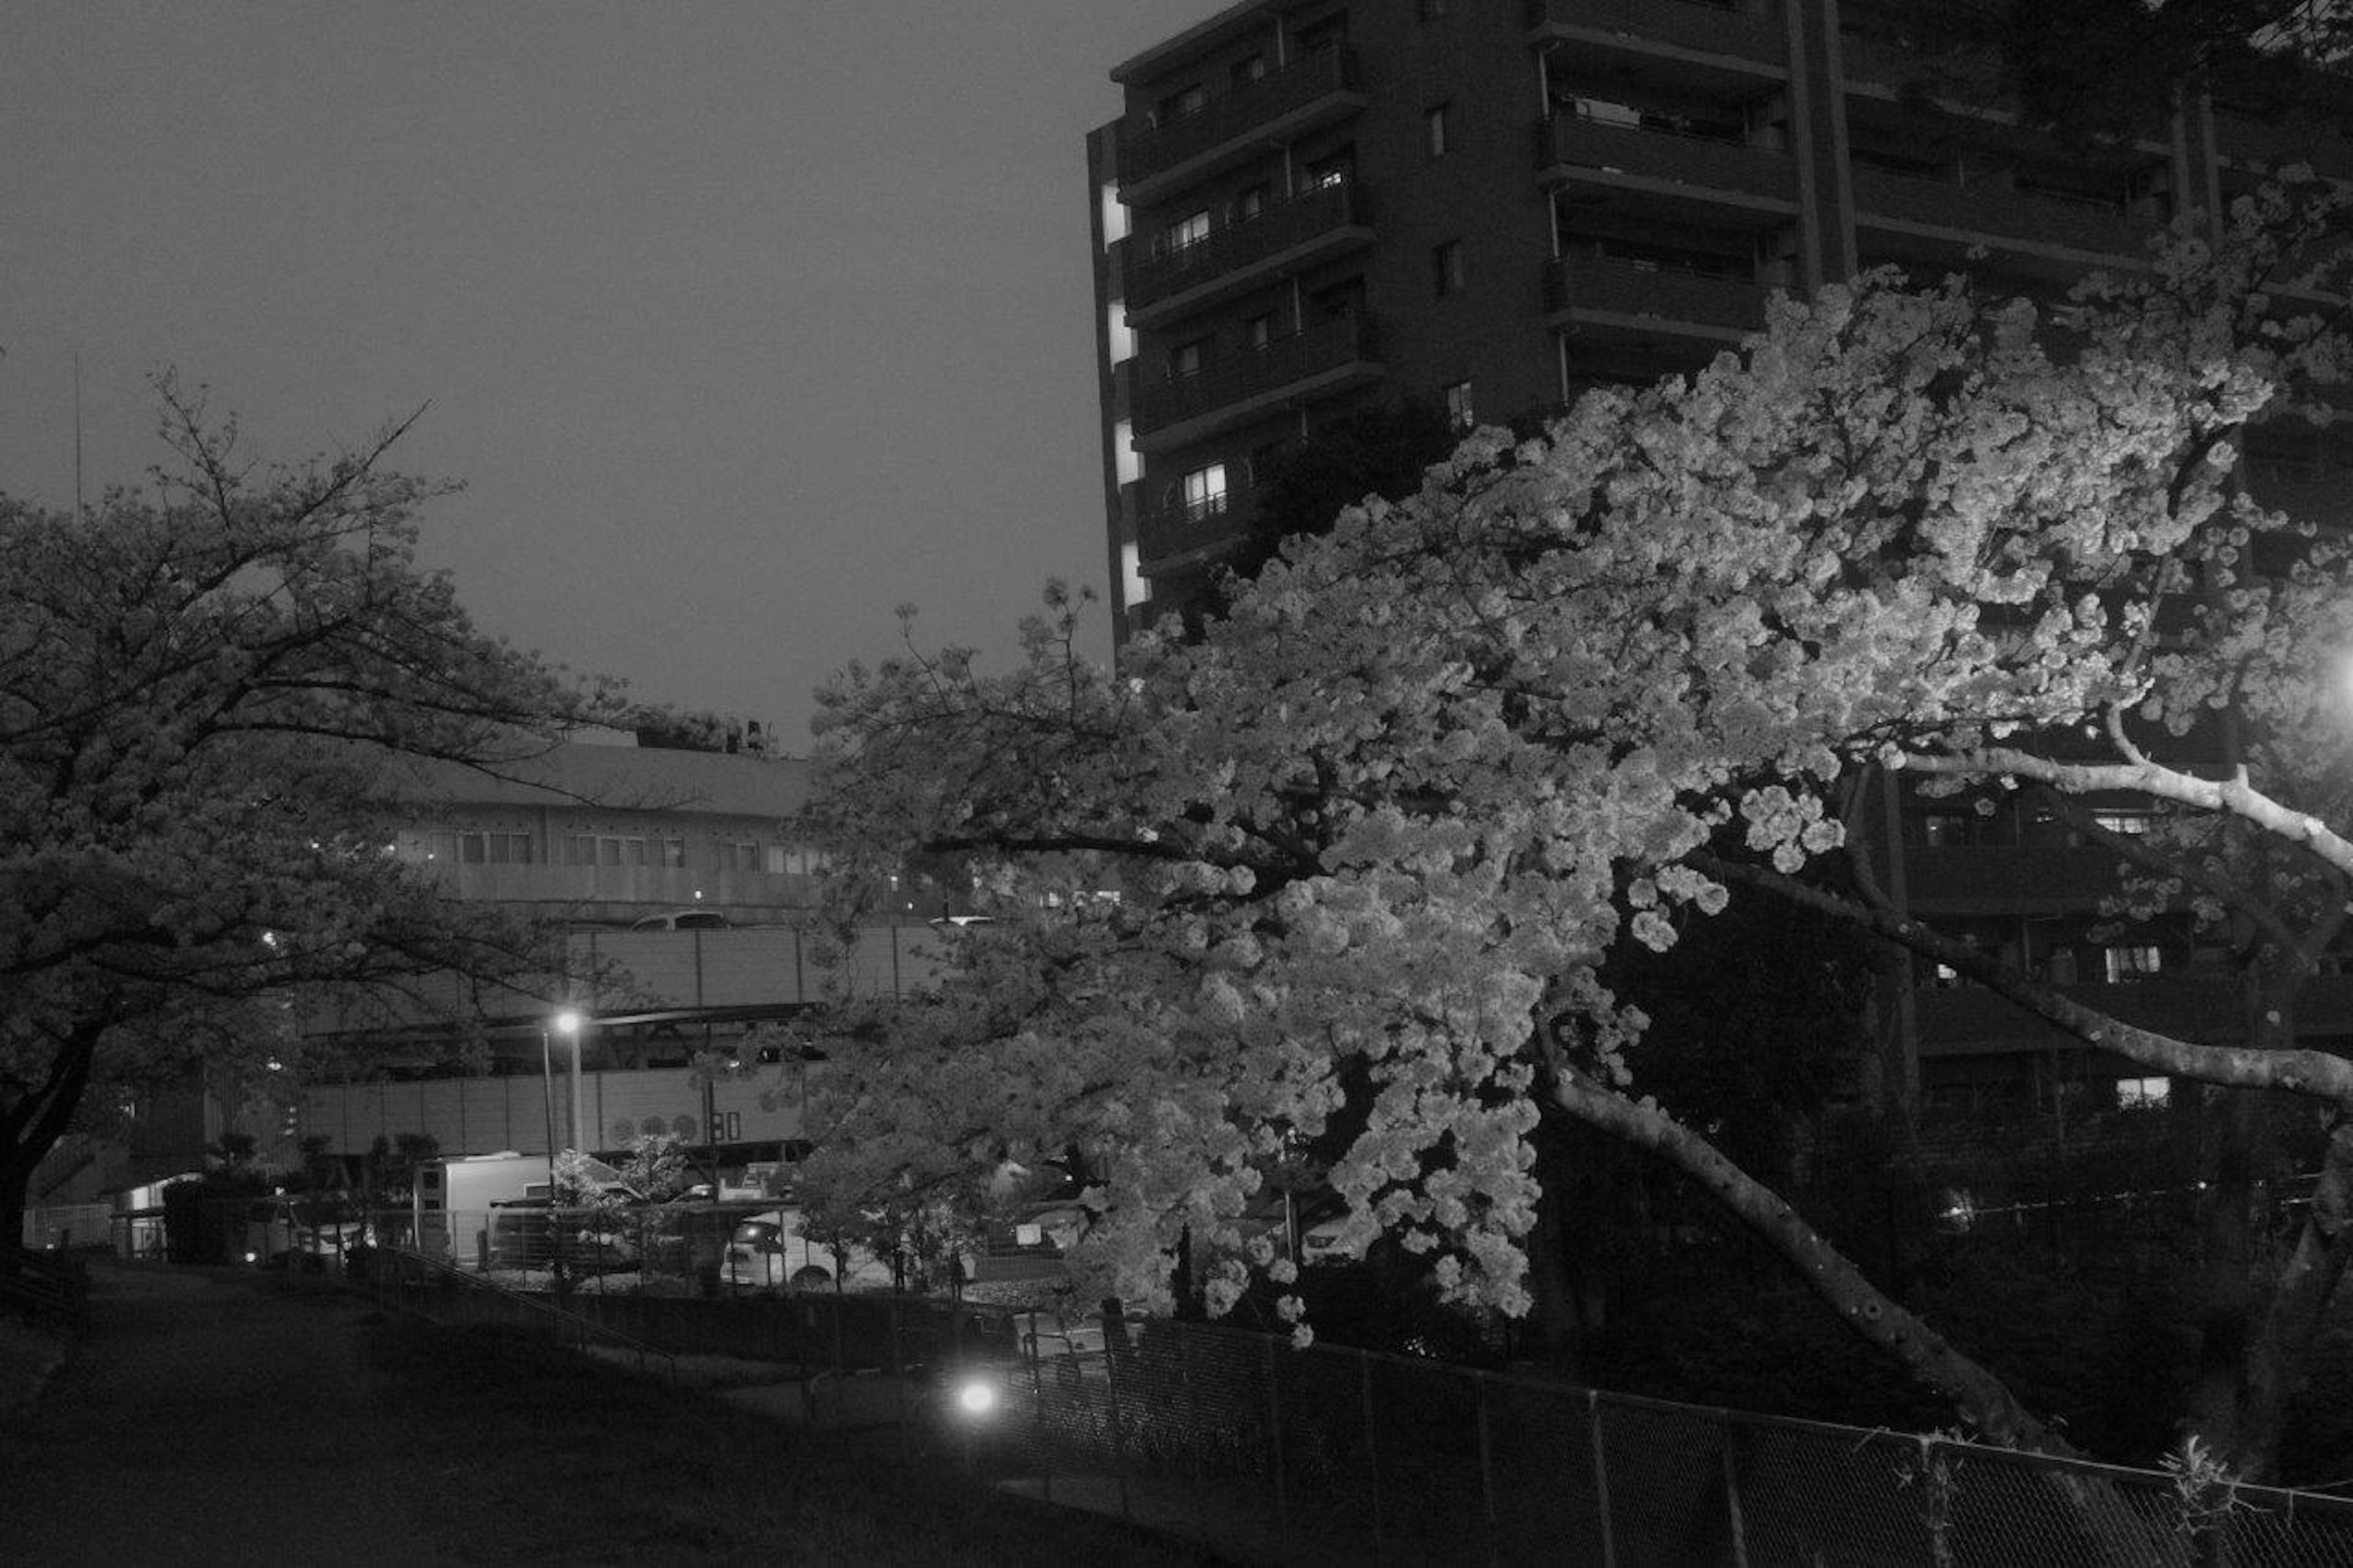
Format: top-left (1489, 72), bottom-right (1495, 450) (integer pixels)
top-left (369, 1321), bottom-right (1219, 1568)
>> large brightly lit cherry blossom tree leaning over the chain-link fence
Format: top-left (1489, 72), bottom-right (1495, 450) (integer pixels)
top-left (812, 186), bottom-right (2353, 1469)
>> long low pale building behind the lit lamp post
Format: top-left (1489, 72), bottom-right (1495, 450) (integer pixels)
top-left (26, 735), bottom-right (960, 1241)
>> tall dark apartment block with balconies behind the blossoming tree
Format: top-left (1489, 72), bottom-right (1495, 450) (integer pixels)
top-left (1087, 0), bottom-right (2353, 1095)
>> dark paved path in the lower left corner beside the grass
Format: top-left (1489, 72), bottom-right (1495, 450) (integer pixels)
top-left (0, 1264), bottom-right (435, 1568)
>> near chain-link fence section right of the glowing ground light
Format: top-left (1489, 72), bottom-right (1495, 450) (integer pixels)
top-left (960, 1321), bottom-right (2353, 1568)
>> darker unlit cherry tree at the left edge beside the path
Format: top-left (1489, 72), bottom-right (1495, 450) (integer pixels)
top-left (0, 379), bottom-right (619, 1246)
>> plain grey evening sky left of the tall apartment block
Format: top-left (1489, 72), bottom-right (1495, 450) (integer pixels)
top-left (0, 0), bottom-right (1195, 751)
